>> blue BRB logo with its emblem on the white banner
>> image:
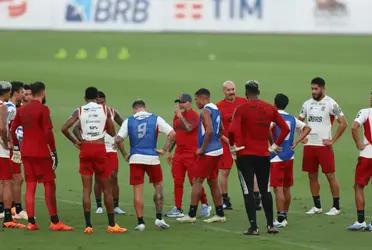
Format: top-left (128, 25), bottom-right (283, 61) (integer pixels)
top-left (66, 0), bottom-right (150, 23)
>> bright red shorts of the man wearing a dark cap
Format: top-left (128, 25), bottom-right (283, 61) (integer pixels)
top-left (172, 153), bottom-right (196, 183)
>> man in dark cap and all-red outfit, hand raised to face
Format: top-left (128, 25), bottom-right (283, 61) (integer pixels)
top-left (166, 93), bottom-right (211, 218)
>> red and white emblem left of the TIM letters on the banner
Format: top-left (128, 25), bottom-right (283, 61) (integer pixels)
top-left (174, 0), bottom-right (204, 20)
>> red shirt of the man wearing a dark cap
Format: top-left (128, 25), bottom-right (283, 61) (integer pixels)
top-left (173, 109), bottom-right (199, 154)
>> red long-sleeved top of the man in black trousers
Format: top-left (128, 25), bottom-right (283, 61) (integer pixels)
top-left (229, 99), bottom-right (289, 156)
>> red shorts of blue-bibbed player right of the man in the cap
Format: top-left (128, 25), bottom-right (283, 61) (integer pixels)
top-left (195, 155), bottom-right (222, 180)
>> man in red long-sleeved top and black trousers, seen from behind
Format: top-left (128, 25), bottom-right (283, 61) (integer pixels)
top-left (229, 81), bottom-right (289, 235)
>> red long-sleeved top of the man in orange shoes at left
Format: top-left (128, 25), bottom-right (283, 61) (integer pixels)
top-left (11, 100), bottom-right (56, 157)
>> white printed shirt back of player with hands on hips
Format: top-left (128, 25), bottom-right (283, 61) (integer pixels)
top-left (79, 102), bottom-right (107, 141)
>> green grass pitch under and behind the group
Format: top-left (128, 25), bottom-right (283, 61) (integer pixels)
top-left (0, 32), bottom-right (372, 250)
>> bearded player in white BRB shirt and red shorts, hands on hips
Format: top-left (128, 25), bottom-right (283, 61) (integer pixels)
top-left (299, 77), bottom-right (347, 216)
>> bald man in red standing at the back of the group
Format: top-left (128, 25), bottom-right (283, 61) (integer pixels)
top-left (217, 81), bottom-right (256, 209)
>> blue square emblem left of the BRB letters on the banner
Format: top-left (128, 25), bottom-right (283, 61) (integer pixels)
top-left (66, 0), bottom-right (92, 22)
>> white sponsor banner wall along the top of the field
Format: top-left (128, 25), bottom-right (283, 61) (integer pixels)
top-left (0, 0), bottom-right (372, 34)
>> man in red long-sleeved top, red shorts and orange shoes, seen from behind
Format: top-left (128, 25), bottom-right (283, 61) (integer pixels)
top-left (11, 82), bottom-right (73, 231)
